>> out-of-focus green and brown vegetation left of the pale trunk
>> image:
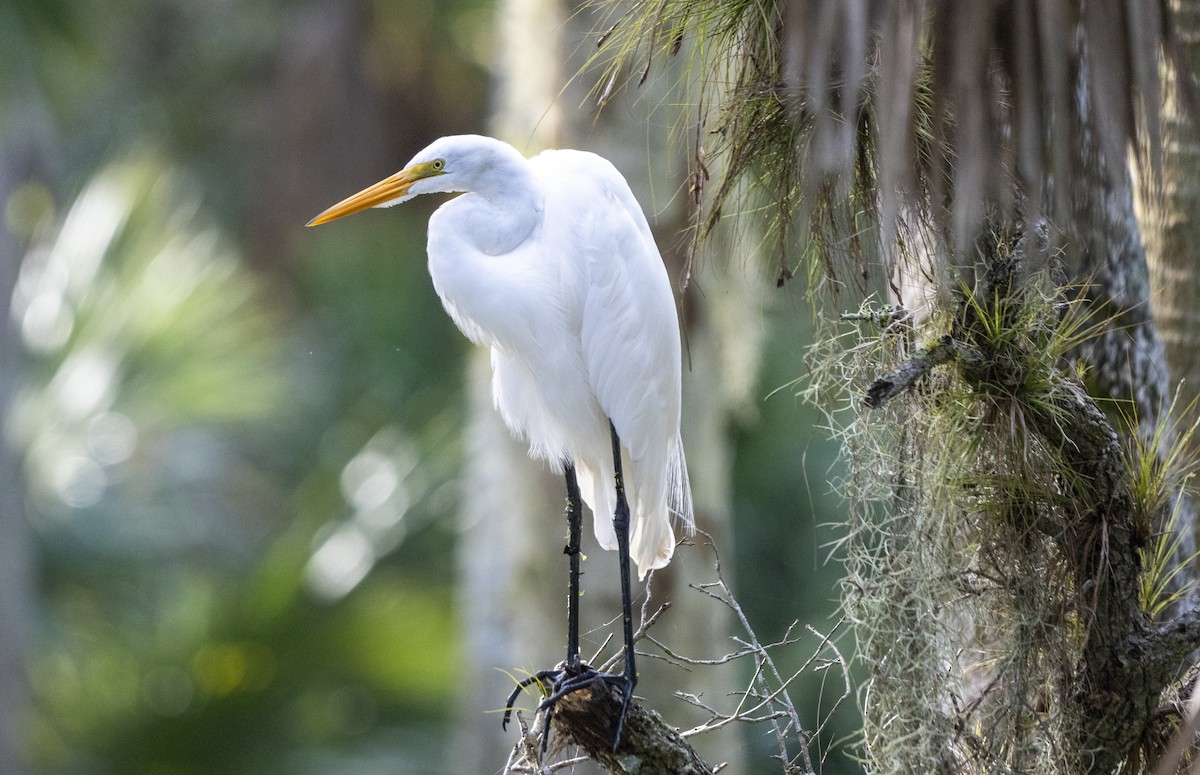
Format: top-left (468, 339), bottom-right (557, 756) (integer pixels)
top-left (0, 0), bottom-right (492, 774)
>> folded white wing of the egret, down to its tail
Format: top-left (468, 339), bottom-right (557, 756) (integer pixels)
top-left (534, 151), bottom-right (691, 572)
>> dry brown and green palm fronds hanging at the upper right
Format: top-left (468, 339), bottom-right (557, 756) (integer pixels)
top-left (598, 0), bottom-right (1198, 287)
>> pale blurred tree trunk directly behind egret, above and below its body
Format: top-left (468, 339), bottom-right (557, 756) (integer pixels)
top-left (456, 0), bottom-right (571, 773)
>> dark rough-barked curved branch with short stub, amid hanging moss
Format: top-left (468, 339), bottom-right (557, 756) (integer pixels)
top-left (864, 262), bottom-right (1200, 773)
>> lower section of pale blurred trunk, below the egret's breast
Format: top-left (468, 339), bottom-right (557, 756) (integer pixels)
top-left (452, 350), bottom-right (566, 773)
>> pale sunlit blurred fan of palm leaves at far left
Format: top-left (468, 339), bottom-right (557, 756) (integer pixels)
top-left (12, 158), bottom-right (282, 507)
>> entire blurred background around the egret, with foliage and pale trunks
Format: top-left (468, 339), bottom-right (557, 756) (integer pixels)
top-left (0, 0), bottom-right (856, 775)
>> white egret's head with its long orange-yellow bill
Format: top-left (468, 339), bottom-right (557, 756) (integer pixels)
top-left (307, 134), bottom-right (520, 226)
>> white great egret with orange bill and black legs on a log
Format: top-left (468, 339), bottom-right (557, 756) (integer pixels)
top-left (308, 134), bottom-right (692, 749)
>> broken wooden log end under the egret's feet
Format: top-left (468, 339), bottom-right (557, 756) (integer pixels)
top-left (554, 680), bottom-right (714, 775)
